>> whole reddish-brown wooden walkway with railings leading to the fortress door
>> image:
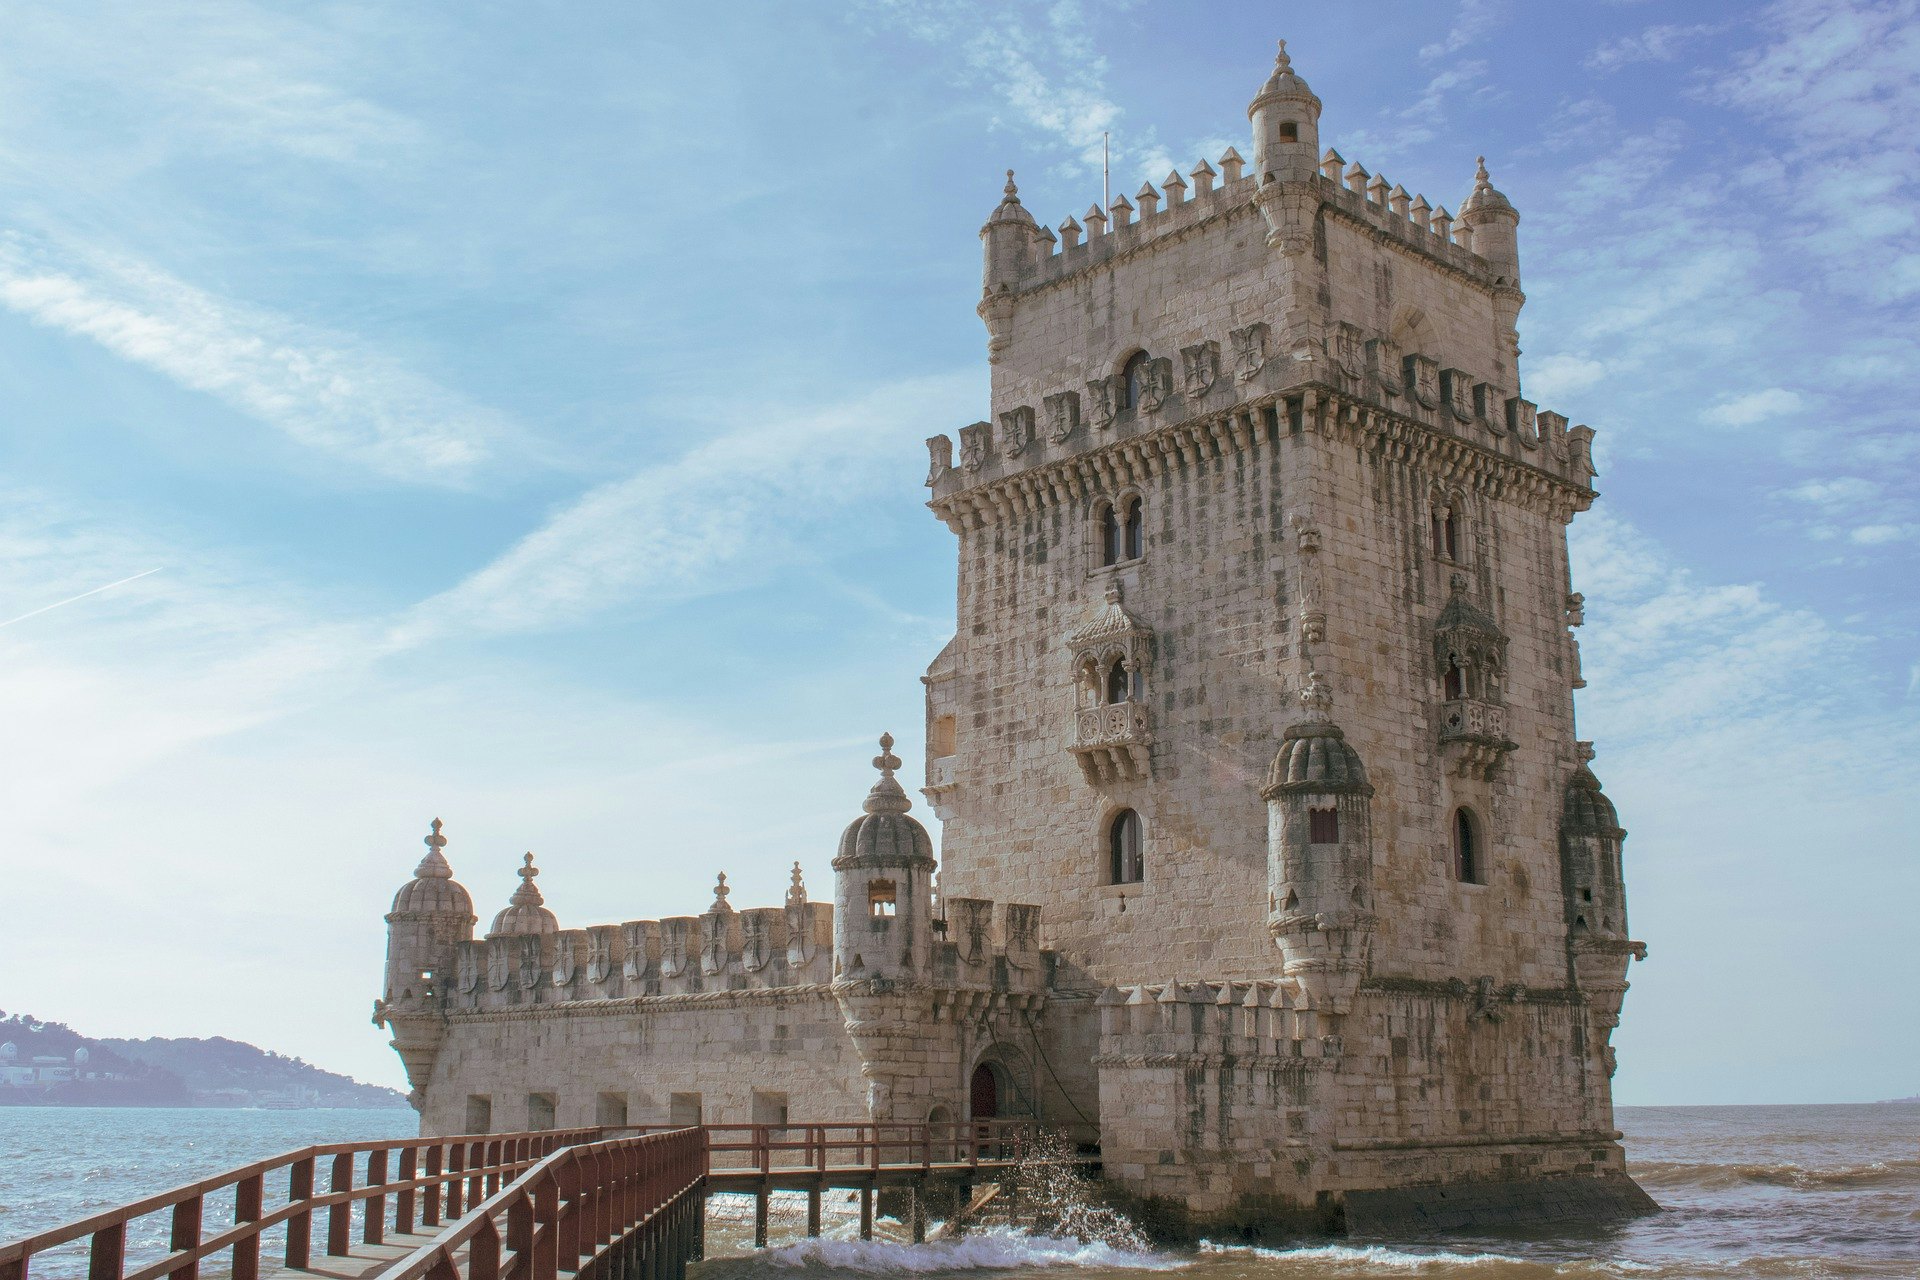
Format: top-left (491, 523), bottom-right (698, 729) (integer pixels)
top-left (0, 1121), bottom-right (1089, 1280)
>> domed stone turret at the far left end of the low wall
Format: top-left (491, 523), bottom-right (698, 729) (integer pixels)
top-left (372, 818), bottom-right (478, 1105)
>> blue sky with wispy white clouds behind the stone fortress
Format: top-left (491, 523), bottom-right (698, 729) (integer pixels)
top-left (0, 0), bottom-right (1920, 1103)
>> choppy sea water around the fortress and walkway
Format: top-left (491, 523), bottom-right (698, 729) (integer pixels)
top-left (0, 1103), bottom-right (1920, 1280)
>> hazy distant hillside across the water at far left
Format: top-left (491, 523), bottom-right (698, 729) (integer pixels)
top-left (0, 1013), bottom-right (407, 1107)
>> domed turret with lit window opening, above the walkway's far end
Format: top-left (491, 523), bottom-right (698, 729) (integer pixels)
top-left (833, 733), bottom-right (935, 983)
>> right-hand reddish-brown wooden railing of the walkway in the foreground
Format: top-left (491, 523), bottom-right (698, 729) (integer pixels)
top-left (380, 1128), bottom-right (707, 1280)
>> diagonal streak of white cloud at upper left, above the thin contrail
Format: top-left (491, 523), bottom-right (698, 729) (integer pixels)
top-left (0, 234), bottom-right (509, 484)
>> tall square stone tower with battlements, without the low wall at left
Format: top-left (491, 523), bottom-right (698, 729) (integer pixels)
top-left (925, 44), bottom-right (1644, 1221)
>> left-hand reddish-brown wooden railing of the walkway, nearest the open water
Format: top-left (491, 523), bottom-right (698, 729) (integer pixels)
top-left (0, 1128), bottom-right (601, 1280)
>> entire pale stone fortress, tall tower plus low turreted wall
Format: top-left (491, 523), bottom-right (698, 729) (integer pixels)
top-left (376, 46), bottom-right (1651, 1232)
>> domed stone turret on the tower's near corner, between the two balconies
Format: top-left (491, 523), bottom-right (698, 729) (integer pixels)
top-left (1260, 672), bottom-right (1375, 1013)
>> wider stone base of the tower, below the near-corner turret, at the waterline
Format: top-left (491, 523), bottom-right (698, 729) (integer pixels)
top-left (1094, 979), bottom-right (1657, 1240)
